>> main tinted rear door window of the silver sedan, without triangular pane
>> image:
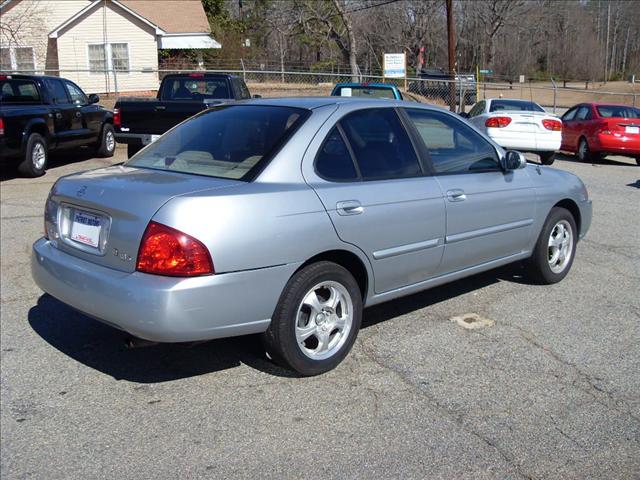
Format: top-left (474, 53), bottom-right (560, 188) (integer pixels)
top-left (340, 108), bottom-right (422, 180)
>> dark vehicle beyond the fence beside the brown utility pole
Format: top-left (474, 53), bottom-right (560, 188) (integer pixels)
top-left (409, 68), bottom-right (476, 105)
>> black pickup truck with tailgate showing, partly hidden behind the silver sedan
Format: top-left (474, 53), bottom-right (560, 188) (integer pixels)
top-left (114, 73), bottom-right (251, 157)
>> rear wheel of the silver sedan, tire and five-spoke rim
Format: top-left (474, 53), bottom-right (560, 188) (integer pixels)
top-left (263, 261), bottom-right (362, 376)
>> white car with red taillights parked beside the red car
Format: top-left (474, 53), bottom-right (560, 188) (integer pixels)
top-left (462, 98), bottom-right (562, 165)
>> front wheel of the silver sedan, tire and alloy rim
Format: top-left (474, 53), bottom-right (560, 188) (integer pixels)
top-left (528, 207), bottom-right (578, 285)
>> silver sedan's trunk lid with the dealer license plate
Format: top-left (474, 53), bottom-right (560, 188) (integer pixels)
top-left (51, 166), bottom-right (244, 272)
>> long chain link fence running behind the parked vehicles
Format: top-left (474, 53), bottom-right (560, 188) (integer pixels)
top-left (3, 65), bottom-right (640, 114)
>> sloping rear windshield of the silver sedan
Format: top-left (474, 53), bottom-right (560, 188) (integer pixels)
top-left (127, 105), bottom-right (309, 181)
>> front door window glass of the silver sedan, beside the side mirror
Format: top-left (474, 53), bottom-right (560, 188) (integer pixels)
top-left (406, 109), bottom-right (500, 174)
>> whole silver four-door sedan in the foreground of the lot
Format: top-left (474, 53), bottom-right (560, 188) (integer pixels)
top-left (31, 97), bottom-right (591, 375)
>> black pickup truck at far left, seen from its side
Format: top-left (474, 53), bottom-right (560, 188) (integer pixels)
top-left (0, 74), bottom-right (116, 177)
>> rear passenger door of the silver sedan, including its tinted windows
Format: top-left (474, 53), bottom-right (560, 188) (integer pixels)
top-left (305, 108), bottom-right (445, 293)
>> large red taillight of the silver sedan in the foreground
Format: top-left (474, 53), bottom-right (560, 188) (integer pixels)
top-left (136, 221), bottom-right (214, 277)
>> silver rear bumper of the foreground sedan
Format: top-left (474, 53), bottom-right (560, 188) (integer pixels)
top-left (31, 238), bottom-right (299, 342)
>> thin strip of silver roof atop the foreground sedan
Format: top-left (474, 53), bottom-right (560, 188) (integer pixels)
top-left (239, 97), bottom-right (448, 111)
